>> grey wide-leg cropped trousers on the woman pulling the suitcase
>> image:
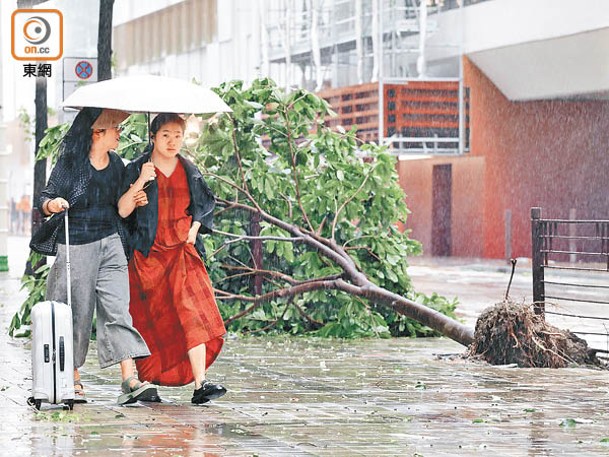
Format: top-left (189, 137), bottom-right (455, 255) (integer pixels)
top-left (46, 233), bottom-right (150, 368)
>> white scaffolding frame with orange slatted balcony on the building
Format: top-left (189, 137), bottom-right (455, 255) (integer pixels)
top-left (262, 0), bottom-right (485, 154)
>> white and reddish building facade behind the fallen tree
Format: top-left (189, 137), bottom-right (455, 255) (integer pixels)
top-left (114, 0), bottom-right (609, 258)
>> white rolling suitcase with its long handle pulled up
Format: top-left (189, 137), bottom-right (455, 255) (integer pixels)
top-left (28, 209), bottom-right (74, 409)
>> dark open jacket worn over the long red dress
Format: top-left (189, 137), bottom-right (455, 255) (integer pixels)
top-left (122, 153), bottom-right (216, 259)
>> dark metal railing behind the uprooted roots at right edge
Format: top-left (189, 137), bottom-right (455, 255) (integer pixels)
top-left (531, 208), bottom-right (609, 352)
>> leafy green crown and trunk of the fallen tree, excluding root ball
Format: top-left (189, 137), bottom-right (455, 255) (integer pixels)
top-left (193, 79), bottom-right (473, 346)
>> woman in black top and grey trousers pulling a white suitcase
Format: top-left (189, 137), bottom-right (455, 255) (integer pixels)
top-left (30, 108), bottom-right (159, 404)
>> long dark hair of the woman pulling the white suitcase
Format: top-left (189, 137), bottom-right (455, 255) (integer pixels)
top-left (59, 108), bottom-right (102, 167)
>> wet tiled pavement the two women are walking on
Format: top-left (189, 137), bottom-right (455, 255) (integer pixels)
top-left (0, 237), bottom-right (609, 457)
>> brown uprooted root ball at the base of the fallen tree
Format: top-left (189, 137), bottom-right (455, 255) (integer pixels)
top-left (468, 301), bottom-right (604, 368)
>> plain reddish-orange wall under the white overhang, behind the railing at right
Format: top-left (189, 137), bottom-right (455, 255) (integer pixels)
top-left (464, 59), bottom-right (609, 258)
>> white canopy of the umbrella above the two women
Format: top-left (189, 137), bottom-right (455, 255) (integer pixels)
top-left (63, 75), bottom-right (232, 114)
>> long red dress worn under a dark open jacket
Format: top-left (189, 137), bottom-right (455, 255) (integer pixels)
top-left (129, 162), bottom-right (226, 386)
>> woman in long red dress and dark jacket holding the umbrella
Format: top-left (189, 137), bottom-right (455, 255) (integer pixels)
top-left (119, 113), bottom-right (226, 404)
